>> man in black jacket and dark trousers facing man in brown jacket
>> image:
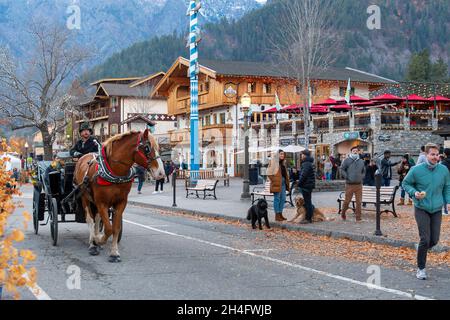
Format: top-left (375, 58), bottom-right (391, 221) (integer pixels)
top-left (298, 150), bottom-right (316, 224)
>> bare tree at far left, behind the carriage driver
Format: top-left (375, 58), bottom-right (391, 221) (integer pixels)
top-left (0, 22), bottom-right (89, 160)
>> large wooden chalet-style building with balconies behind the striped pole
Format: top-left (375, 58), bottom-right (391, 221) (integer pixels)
top-left (152, 57), bottom-right (395, 176)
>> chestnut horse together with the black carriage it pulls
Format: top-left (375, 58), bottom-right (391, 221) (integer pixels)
top-left (33, 129), bottom-right (165, 263)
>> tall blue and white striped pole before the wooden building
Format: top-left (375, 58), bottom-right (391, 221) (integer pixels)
top-left (189, 0), bottom-right (200, 172)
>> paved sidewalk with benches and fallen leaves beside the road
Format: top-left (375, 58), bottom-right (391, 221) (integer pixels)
top-left (129, 179), bottom-right (450, 252)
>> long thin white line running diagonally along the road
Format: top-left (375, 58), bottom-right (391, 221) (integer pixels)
top-left (123, 219), bottom-right (434, 300)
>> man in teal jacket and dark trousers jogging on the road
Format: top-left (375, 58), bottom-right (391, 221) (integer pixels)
top-left (402, 143), bottom-right (450, 280)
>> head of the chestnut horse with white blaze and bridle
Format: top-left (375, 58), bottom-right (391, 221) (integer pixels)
top-left (134, 129), bottom-right (166, 180)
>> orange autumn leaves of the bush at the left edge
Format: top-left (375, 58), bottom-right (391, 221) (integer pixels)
top-left (0, 140), bottom-right (37, 299)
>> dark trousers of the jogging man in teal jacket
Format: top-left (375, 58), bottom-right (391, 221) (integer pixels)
top-left (414, 207), bottom-right (442, 269)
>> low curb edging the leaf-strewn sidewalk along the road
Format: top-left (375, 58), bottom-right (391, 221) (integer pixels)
top-left (128, 201), bottom-right (450, 253)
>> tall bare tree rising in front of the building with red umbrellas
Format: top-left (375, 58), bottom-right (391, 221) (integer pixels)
top-left (271, 0), bottom-right (339, 148)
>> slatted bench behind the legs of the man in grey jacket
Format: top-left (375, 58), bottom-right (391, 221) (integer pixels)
top-left (337, 186), bottom-right (398, 218)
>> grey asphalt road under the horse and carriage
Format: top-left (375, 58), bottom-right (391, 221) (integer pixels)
top-left (4, 190), bottom-right (450, 300)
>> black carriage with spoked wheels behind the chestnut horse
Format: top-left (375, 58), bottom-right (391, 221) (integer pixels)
top-left (33, 152), bottom-right (122, 246)
